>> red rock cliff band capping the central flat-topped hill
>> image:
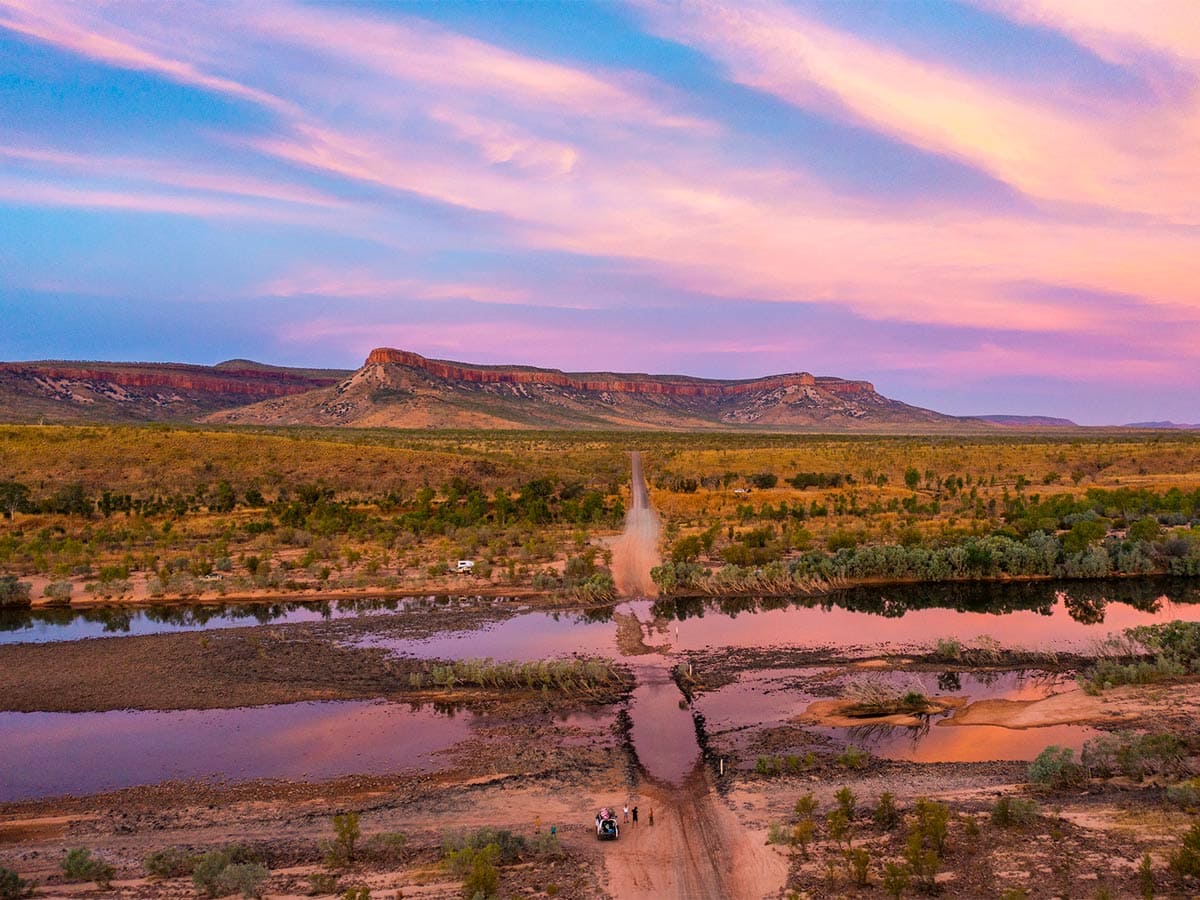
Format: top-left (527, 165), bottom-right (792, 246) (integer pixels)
top-left (366, 347), bottom-right (875, 397)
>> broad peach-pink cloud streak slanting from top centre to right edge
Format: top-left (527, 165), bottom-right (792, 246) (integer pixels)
top-left (628, 1), bottom-right (1200, 224)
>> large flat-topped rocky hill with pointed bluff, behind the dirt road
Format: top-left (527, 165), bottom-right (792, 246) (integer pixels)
top-left (209, 348), bottom-right (974, 431)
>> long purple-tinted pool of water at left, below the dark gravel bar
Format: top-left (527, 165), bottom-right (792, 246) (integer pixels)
top-left (0, 701), bottom-right (474, 802)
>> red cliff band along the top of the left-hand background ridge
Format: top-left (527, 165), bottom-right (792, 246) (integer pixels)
top-left (0, 362), bottom-right (330, 398)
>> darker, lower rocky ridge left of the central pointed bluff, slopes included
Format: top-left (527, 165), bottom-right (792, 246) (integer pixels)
top-left (0, 360), bottom-right (350, 422)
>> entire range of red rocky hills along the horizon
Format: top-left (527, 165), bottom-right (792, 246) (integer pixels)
top-left (0, 348), bottom-right (1196, 432)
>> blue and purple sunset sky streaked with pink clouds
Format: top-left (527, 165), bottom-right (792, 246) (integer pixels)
top-left (0, 0), bottom-right (1200, 424)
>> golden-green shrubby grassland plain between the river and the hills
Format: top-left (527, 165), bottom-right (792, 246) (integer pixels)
top-left (0, 426), bottom-right (1200, 602)
